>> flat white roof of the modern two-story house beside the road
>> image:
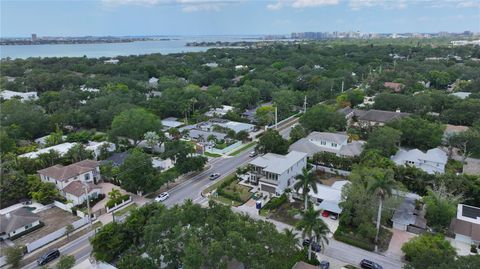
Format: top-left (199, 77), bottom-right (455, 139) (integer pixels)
top-left (250, 151), bottom-right (307, 175)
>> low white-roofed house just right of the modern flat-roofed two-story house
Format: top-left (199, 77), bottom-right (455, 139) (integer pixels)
top-left (309, 180), bottom-right (350, 214)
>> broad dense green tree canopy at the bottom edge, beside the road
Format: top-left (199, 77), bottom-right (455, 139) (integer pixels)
top-left (91, 201), bottom-right (301, 268)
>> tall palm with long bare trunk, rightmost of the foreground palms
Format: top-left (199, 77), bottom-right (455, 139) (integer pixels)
top-left (368, 171), bottom-right (396, 243)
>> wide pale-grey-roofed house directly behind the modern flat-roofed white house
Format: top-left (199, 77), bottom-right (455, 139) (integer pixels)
top-left (290, 132), bottom-right (365, 157)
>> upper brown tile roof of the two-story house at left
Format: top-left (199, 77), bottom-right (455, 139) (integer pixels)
top-left (37, 160), bottom-right (98, 181)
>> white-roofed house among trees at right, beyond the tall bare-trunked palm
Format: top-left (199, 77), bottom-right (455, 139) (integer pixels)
top-left (391, 148), bottom-right (448, 174)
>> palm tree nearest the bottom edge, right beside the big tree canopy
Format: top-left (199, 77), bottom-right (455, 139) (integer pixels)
top-left (295, 206), bottom-right (330, 260)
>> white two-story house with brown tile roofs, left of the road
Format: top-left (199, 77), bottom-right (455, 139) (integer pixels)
top-left (37, 160), bottom-right (101, 205)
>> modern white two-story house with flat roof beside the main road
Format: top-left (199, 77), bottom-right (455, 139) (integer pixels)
top-left (248, 151), bottom-right (307, 195)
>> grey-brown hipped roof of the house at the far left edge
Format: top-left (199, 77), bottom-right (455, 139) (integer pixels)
top-left (0, 207), bottom-right (40, 233)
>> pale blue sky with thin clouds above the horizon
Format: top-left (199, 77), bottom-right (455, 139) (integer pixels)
top-left (0, 0), bottom-right (480, 37)
